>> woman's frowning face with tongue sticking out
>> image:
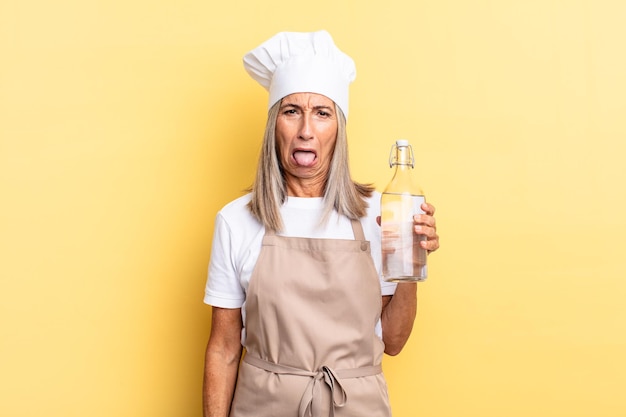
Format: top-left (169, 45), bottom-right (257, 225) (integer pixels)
top-left (276, 93), bottom-right (337, 197)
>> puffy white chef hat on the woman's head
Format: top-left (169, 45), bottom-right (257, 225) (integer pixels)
top-left (243, 30), bottom-right (356, 118)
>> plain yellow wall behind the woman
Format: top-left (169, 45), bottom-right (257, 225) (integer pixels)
top-left (0, 0), bottom-right (626, 417)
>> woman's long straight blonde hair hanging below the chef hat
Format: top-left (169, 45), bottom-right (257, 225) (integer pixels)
top-left (248, 101), bottom-right (374, 231)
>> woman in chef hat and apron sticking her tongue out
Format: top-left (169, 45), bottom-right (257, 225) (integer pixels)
top-left (204, 31), bottom-right (439, 417)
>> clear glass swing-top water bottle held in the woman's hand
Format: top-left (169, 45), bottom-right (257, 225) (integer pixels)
top-left (381, 139), bottom-right (427, 282)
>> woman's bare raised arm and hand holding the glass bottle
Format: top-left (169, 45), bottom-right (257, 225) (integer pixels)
top-left (381, 203), bottom-right (439, 356)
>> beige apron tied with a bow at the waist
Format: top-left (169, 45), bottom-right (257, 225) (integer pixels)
top-left (230, 221), bottom-right (391, 417)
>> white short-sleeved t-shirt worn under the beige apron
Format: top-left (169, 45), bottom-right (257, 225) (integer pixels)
top-left (204, 192), bottom-right (396, 341)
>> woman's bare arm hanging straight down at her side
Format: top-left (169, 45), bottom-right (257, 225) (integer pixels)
top-left (202, 307), bottom-right (243, 417)
